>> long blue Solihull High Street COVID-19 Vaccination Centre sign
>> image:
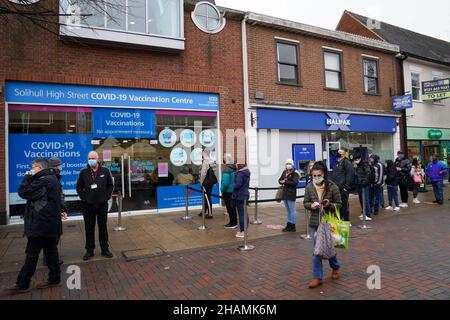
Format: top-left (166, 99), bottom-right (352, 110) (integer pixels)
top-left (5, 81), bottom-right (219, 111)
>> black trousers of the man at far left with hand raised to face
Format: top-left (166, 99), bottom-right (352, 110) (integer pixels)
top-left (16, 237), bottom-right (61, 289)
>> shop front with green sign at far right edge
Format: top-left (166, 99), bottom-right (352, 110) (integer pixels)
top-left (407, 127), bottom-right (450, 164)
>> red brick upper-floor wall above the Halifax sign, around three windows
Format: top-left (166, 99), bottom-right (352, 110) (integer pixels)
top-left (248, 25), bottom-right (397, 112)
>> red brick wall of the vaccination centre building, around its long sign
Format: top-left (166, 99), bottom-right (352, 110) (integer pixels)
top-left (0, 0), bottom-right (244, 215)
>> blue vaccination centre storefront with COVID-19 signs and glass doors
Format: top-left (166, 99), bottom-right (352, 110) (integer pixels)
top-left (5, 81), bottom-right (220, 219)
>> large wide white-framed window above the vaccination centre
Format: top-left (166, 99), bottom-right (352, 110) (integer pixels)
top-left (61, 0), bottom-right (183, 38)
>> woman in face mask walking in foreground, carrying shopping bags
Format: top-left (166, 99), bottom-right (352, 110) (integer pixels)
top-left (303, 162), bottom-right (342, 289)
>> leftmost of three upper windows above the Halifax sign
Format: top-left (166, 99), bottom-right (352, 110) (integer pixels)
top-left (277, 41), bottom-right (299, 84)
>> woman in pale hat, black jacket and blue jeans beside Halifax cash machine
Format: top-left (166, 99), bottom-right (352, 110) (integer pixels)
top-left (278, 159), bottom-right (300, 232)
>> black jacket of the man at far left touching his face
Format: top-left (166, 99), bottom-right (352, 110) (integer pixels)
top-left (18, 169), bottom-right (62, 238)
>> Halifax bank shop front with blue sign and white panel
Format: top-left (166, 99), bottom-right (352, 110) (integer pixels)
top-left (251, 108), bottom-right (400, 200)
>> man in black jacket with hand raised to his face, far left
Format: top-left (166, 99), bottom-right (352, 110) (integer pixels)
top-left (10, 158), bottom-right (62, 293)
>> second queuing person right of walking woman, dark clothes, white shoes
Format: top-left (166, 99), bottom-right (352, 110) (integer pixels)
top-left (353, 154), bottom-right (372, 221)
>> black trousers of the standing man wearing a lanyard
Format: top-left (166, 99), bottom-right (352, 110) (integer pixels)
top-left (83, 202), bottom-right (109, 251)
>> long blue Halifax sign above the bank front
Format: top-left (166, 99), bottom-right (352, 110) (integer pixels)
top-left (257, 109), bottom-right (397, 133)
